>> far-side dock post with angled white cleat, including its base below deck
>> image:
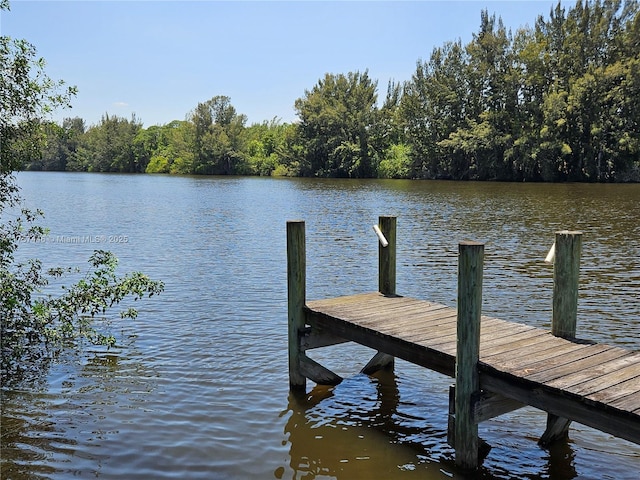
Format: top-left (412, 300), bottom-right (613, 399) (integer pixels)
top-left (360, 216), bottom-right (397, 375)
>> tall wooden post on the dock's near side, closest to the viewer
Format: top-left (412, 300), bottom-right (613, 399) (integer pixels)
top-left (454, 242), bottom-right (484, 470)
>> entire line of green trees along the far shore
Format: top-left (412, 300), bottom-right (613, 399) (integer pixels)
top-left (26, 0), bottom-right (640, 182)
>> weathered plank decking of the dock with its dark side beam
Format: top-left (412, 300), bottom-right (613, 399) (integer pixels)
top-left (303, 292), bottom-right (640, 444)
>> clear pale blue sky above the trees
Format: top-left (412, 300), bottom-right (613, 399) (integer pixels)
top-left (0, 0), bottom-right (560, 127)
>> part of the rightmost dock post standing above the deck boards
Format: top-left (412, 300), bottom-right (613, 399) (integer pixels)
top-left (551, 230), bottom-right (582, 339)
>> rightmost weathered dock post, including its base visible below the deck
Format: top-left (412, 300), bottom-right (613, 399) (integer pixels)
top-left (538, 230), bottom-right (582, 446)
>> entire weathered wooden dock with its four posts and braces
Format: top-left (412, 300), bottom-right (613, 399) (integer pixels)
top-left (287, 217), bottom-right (640, 469)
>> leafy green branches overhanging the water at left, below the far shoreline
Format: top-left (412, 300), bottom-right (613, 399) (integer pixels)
top-left (0, 183), bottom-right (164, 385)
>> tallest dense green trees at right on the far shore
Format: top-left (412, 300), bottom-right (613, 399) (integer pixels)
top-left (403, 1), bottom-right (640, 181)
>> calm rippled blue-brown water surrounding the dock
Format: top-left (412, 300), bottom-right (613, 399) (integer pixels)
top-left (1, 173), bottom-right (640, 480)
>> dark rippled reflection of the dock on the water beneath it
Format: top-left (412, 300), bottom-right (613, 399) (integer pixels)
top-left (274, 371), bottom-right (600, 480)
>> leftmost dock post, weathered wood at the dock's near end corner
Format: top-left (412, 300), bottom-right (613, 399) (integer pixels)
top-left (287, 220), bottom-right (307, 391)
